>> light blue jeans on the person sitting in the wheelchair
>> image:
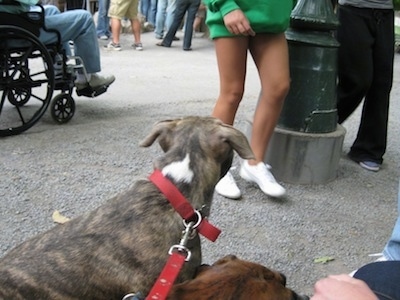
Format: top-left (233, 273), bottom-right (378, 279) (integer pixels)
top-left (39, 5), bottom-right (101, 73)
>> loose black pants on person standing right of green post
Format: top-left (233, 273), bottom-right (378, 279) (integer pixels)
top-left (337, 5), bottom-right (394, 163)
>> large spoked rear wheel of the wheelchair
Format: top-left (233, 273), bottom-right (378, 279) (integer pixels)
top-left (0, 25), bottom-right (54, 136)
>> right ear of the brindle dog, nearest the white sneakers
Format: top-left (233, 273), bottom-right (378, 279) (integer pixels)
top-left (221, 124), bottom-right (255, 159)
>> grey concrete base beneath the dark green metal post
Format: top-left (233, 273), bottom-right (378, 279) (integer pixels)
top-left (245, 121), bottom-right (346, 184)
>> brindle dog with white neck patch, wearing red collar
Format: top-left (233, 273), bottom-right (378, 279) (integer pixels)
top-left (0, 117), bottom-right (253, 300)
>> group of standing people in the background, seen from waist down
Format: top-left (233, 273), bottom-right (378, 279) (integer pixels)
top-left (97, 0), bottom-right (205, 51)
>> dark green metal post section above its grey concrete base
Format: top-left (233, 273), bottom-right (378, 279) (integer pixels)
top-left (277, 0), bottom-right (339, 133)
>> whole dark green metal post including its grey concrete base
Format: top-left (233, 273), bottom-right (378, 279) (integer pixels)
top-left (252, 0), bottom-right (346, 184)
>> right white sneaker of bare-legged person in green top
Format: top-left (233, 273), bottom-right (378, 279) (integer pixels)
top-left (240, 160), bottom-right (286, 198)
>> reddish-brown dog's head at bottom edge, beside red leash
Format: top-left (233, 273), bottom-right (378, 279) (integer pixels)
top-left (167, 255), bottom-right (309, 300)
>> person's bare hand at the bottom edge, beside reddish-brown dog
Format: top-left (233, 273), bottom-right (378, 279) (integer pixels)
top-left (311, 274), bottom-right (378, 300)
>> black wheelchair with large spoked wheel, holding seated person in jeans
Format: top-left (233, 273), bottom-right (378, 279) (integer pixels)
top-left (0, 0), bottom-right (108, 137)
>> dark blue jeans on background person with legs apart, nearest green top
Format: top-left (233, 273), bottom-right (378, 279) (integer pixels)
top-left (163, 0), bottom-right (200, 49)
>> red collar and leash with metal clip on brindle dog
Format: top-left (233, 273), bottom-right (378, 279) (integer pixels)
top-left (146, 170), bottom-right (221, 300)
